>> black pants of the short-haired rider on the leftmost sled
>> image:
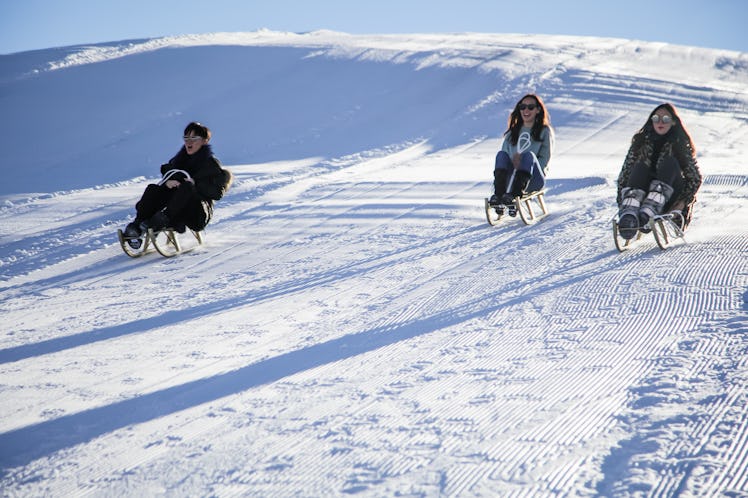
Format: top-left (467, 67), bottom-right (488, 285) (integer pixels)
top-left (135, 182), bottom-right (210, 231)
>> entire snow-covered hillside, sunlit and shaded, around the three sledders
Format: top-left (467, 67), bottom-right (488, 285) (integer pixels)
top-left (0, 31), bottom-right (748, 497)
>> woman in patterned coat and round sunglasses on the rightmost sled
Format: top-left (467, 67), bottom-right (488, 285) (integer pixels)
top-left (616, 103), bottom-right (701, 239)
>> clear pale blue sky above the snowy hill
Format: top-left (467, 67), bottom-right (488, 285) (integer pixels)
top-left (0, 0), bottom-right (748, 54)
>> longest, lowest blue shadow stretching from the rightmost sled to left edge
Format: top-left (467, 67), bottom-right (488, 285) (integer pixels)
top-left (0, 245), bottom-right (617, 475)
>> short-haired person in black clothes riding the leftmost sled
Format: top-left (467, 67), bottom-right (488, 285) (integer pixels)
top-left (125, 122), bottom-right (232, 238)
